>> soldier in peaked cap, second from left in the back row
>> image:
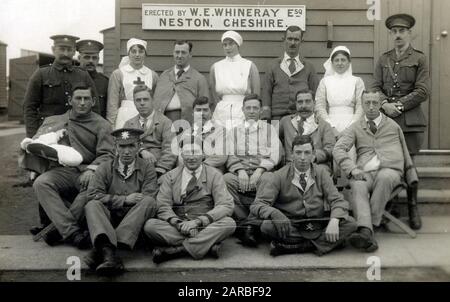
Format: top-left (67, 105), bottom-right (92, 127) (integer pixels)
top-left (77, 40), bottom-right (109, 118)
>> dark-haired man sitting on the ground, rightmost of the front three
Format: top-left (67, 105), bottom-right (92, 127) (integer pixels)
top-left (250, 135), bottom-right (356, 256)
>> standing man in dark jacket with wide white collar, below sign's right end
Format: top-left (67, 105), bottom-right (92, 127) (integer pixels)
top-left (261, 26), bottom-right (319, 120)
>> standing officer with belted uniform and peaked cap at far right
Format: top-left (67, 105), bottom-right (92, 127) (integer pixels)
top-left (372, 14), bottom-right (429, 229)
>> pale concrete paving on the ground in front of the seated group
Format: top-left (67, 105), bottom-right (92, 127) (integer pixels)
top-left (0, 217), bottom-right (450, 281)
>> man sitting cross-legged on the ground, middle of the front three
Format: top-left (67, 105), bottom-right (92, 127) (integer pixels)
top-left (144, 140), bottom-right (236, 263)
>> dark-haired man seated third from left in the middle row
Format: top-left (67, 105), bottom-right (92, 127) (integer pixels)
top-left (172, 96), bottom-right (232, 171)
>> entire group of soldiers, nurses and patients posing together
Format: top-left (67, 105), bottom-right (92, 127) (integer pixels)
top-left (21, 14), bottom-right (429, 274)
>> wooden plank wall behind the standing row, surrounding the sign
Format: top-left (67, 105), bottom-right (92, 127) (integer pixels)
top-left (115, 0), bottom-right (375, 88)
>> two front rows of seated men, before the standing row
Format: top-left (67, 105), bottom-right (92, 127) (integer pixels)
top-left (23, 83), bottom-right (418, 274)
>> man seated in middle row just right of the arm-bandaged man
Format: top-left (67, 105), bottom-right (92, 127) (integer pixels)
top-left (124, 85), bottom-right (177, 178)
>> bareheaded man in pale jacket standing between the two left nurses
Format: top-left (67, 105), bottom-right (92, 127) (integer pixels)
top-left (155, 40), bottom-right (209, 124)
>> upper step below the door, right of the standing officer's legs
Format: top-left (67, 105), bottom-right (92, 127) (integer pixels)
top-left (417, 166), bottom-right (450, 190)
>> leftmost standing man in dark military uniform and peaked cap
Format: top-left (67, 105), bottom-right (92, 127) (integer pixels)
top-left (23, 35), bottom-right (99, 137)
